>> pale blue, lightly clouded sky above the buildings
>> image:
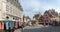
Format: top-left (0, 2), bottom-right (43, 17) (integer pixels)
top-left (19, 0), bottom-right (60, 18)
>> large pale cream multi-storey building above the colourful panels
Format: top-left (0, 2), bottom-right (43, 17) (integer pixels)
top-left (0, 0), bottom-right (23, 20)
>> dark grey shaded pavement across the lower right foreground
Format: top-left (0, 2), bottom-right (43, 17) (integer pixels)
top-left (23, 27), bottom-right (60, 32)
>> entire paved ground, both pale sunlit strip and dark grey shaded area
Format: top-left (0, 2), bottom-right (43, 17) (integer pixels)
top-left (14, 26), bottom-right (60, 32)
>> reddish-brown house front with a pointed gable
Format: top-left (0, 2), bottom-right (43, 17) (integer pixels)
top-left (39, 11), bottom-right (51, 25)
